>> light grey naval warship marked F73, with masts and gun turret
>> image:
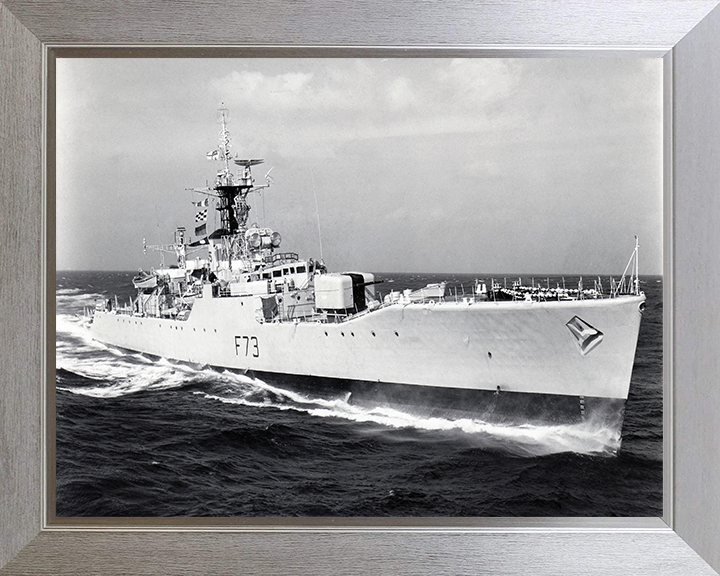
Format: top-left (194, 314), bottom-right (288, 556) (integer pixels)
top-left (91, 108), bottom-right (645, 431)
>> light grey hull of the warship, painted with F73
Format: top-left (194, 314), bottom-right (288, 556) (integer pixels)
top-left (92, 292), bottom-right (645, 420)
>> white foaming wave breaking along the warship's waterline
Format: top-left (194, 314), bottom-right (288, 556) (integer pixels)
top-left (57, 345), bottom-right (620, 456)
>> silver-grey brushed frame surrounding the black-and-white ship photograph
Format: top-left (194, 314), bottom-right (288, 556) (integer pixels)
top-left (0, 0), bottom-right (720, 575)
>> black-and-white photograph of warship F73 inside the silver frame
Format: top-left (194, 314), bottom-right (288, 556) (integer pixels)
top-left (55, 57), bottom-right (663, 518)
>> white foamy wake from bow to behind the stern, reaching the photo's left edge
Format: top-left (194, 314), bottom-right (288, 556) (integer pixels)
top-left (56, 315), bottom-right (620, 457)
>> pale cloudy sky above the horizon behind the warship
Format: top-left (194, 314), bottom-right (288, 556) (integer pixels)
top-left (56, 58), bottom-right (662, 275)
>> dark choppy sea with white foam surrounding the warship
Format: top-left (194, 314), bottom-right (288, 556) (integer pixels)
top-left (55, 272), bottom-right (662, 517)
